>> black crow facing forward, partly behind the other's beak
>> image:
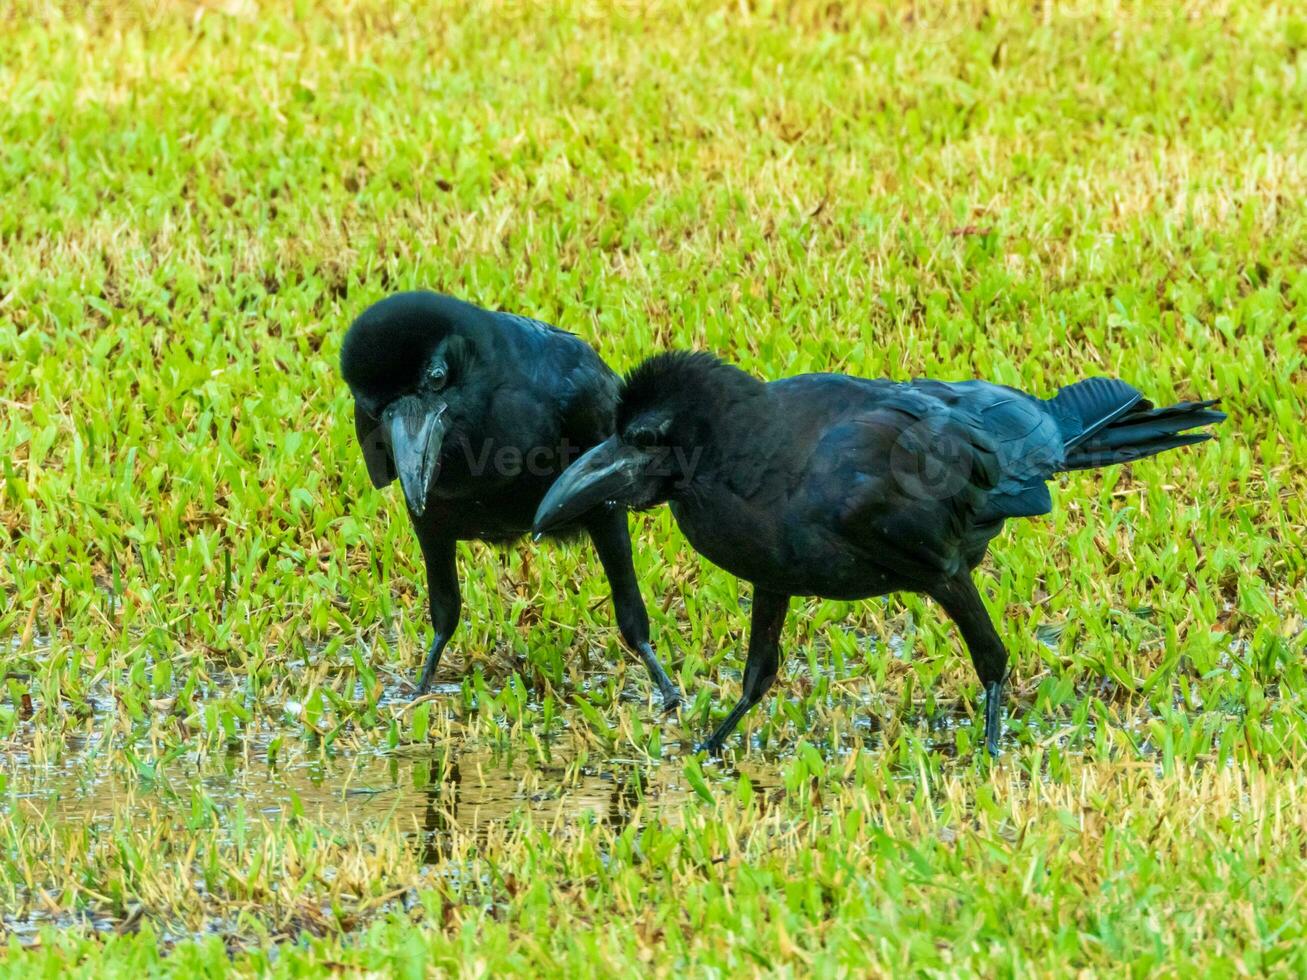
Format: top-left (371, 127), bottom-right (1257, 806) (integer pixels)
top-left (340, 293), bottom-right (681, 710)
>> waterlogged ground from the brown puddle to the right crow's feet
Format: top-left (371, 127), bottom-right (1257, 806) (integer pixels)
top-left (0, 624), bottom-right (1233, 938)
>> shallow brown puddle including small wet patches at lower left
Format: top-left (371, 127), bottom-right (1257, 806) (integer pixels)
top-left (0, 725), bottom-right (775, 941)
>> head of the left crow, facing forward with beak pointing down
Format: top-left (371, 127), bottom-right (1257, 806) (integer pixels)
top-left (340, 293), bottom-right (491, 516)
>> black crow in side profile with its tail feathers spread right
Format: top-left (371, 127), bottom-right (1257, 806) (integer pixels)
top-left (533, 351), bottom-right (1225, 754)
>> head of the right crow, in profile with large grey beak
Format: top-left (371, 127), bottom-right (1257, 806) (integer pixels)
top-left (532, 350), bottom-right (762, 536)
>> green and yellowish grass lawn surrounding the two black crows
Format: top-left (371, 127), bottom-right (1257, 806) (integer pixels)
top-left (0, 0), bottom-right (1307, 976)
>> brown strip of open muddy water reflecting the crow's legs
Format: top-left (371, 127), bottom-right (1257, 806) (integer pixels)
top-left (10, 746), bottom-right (747, 860)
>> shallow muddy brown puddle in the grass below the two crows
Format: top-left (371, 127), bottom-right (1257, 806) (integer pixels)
top-left (0, 695), bottom-right (779, 864)
